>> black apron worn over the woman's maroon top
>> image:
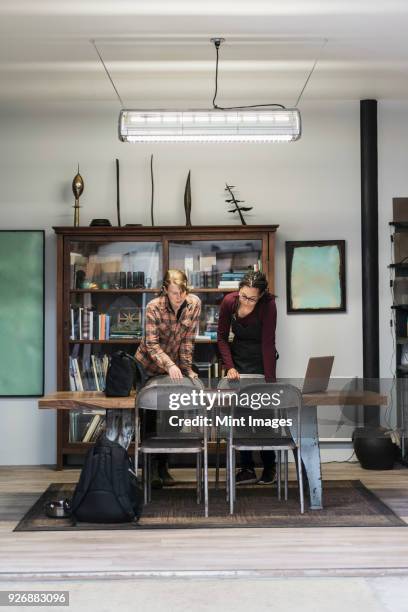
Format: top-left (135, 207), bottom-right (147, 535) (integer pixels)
top-left (231, 305), bottom-right (264, 374)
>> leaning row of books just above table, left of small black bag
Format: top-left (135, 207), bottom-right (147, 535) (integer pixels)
top-left (69, 355), bottom-right (109, 391)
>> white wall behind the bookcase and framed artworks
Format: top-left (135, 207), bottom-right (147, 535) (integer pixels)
top-left (0, 102), bottom-right (368, 465)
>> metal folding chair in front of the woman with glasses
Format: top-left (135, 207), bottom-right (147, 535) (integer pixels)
top-left (218, 374), bottom-right (304, 514)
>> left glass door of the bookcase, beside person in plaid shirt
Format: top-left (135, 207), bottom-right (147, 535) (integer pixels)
top-left (67, 240), bottom-right (163, 392)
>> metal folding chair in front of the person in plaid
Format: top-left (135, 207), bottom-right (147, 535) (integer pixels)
top-left (135, 376), bottom-right (208, 517)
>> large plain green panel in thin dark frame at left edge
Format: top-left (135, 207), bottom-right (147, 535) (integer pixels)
top-left (0, 230), bottom-right (44, 397)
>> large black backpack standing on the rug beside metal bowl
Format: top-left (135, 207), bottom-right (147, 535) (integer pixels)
top-left (71, 438), bottom-right (143, 523)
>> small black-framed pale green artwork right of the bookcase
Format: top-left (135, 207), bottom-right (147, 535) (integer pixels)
top-left (286, 240), bottom-right (346, 314)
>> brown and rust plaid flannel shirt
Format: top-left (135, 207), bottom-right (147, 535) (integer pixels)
top-left (136, 294), bottom-right (201, 376)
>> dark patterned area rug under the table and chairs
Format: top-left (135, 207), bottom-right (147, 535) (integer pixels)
top-left (14, 480), bottom-right (406, 531)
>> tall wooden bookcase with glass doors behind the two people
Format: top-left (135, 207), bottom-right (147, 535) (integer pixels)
top-left (54, 225), bottom-right (278, 469)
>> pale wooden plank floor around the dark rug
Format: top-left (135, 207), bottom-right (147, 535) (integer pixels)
top-left (0, 463), bottom-right (408, 580)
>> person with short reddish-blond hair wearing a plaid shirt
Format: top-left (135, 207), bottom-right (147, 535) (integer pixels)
top-left (136, 270), bottom-right (201, 486)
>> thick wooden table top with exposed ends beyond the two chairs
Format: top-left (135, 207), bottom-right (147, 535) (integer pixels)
top-left (38, 390), bottom-right (388, 410)
